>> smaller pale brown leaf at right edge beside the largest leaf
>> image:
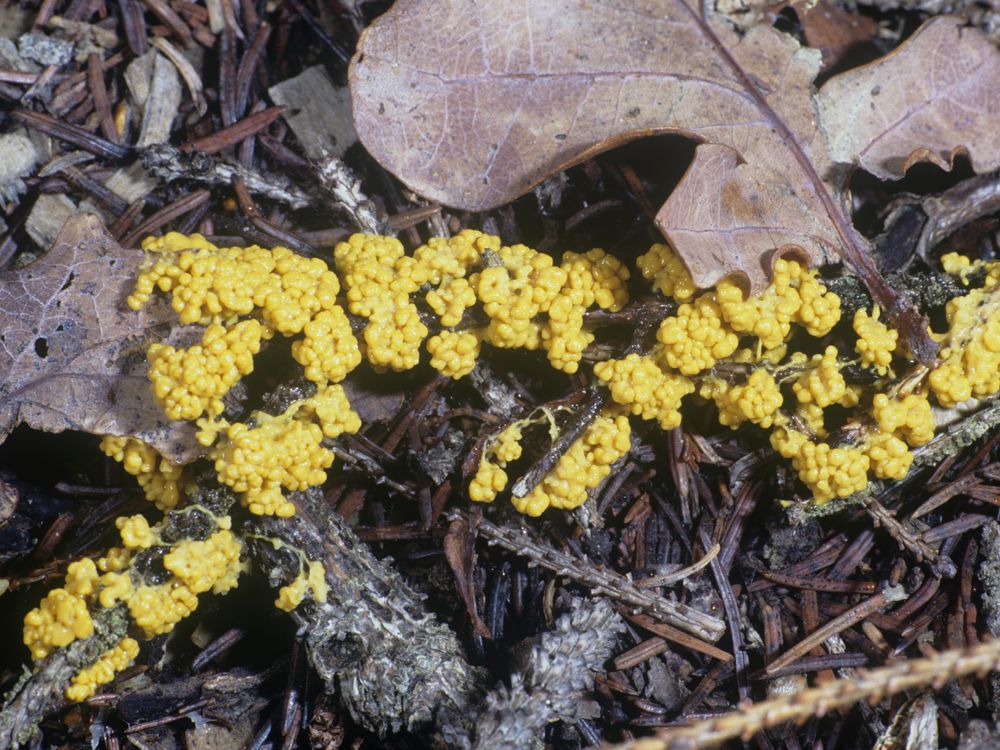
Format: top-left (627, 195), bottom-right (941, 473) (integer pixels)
top-left (817, 16), bottom-right (1000, 180)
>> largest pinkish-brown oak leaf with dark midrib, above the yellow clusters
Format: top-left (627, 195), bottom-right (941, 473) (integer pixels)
top-left (351, 0), bottom-right (836, 287)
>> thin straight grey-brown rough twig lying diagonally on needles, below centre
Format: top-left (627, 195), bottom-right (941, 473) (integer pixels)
top-left (448, 509), bottom-right (726, 643)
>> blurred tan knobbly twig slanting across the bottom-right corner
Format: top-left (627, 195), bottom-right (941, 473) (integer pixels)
top-left (616, 641), bottom-right (1000, 750)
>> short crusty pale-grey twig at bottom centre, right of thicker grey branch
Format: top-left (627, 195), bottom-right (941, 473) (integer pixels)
top-left (472, 599), bottom-right (624, 750)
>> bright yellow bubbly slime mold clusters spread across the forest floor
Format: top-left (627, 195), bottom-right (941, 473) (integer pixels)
top-left (24, 230), bottom-right (1000, 700)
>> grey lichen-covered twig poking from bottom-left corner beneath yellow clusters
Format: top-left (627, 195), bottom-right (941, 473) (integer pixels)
top-left (0, 606), bottom-right (128, 748)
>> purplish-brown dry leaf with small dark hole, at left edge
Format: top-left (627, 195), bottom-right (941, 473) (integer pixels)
top-left (0, 214), bottom-right (198, 462)
